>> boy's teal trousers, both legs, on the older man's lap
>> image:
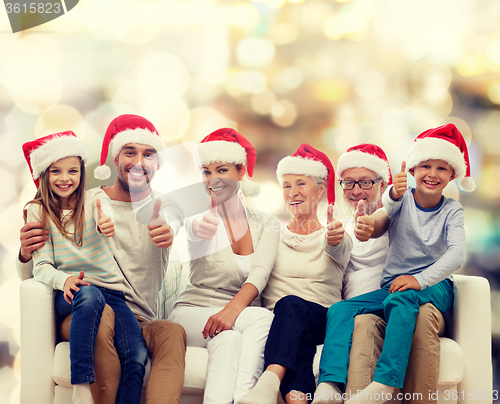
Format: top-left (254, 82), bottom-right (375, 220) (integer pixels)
top-left (319, 279), bottom-right (453, 388)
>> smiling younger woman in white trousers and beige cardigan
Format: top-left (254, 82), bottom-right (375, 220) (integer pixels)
top-left (169, 128), bottom-right (280, 404)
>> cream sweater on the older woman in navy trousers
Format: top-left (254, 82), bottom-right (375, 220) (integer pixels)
top-left (262, 227), bottom-right (352, 310)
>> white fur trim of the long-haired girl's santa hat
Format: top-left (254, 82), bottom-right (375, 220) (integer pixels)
top-left (30, 136), bottom-right (89, 180)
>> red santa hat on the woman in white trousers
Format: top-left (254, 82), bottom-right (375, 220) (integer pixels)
top-left (194, 128), bottom-right (260, 196)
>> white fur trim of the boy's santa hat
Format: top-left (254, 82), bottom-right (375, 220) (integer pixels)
top-left (406, 137), bottom-right (467, 180)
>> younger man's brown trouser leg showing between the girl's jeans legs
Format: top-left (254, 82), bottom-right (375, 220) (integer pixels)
top-left (60, 304), bottom-right (121, 404)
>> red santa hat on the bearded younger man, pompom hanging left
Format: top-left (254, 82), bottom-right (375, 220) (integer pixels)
top-left (94, 114), bottom-right (165, 180)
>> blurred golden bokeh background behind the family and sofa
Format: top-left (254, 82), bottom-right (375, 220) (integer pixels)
top-left (0, 0), bottom-right (500, 404)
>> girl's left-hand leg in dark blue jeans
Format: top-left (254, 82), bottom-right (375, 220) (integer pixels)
top-left (56, 285), bottom-right (106, 384)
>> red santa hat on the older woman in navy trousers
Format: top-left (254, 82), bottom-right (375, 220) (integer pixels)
top-left (276, 143), bottom-right (335, 205)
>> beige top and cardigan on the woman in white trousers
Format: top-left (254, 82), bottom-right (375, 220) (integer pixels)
top-left (176, 209), bottom-right (280, 307)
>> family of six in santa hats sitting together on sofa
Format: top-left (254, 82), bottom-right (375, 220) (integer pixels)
top-left (18, 115), bottom-right (474, 404)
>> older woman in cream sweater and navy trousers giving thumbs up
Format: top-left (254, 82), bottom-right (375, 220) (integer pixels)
top-left (237, 144), bottom-right (352, 404)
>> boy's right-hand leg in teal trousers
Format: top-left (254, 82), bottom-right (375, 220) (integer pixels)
top-left (373, 279), bottom-right (453, 388)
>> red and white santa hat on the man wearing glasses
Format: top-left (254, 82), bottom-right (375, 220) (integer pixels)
top-left (337, 143), bottom-right (392, 185)
